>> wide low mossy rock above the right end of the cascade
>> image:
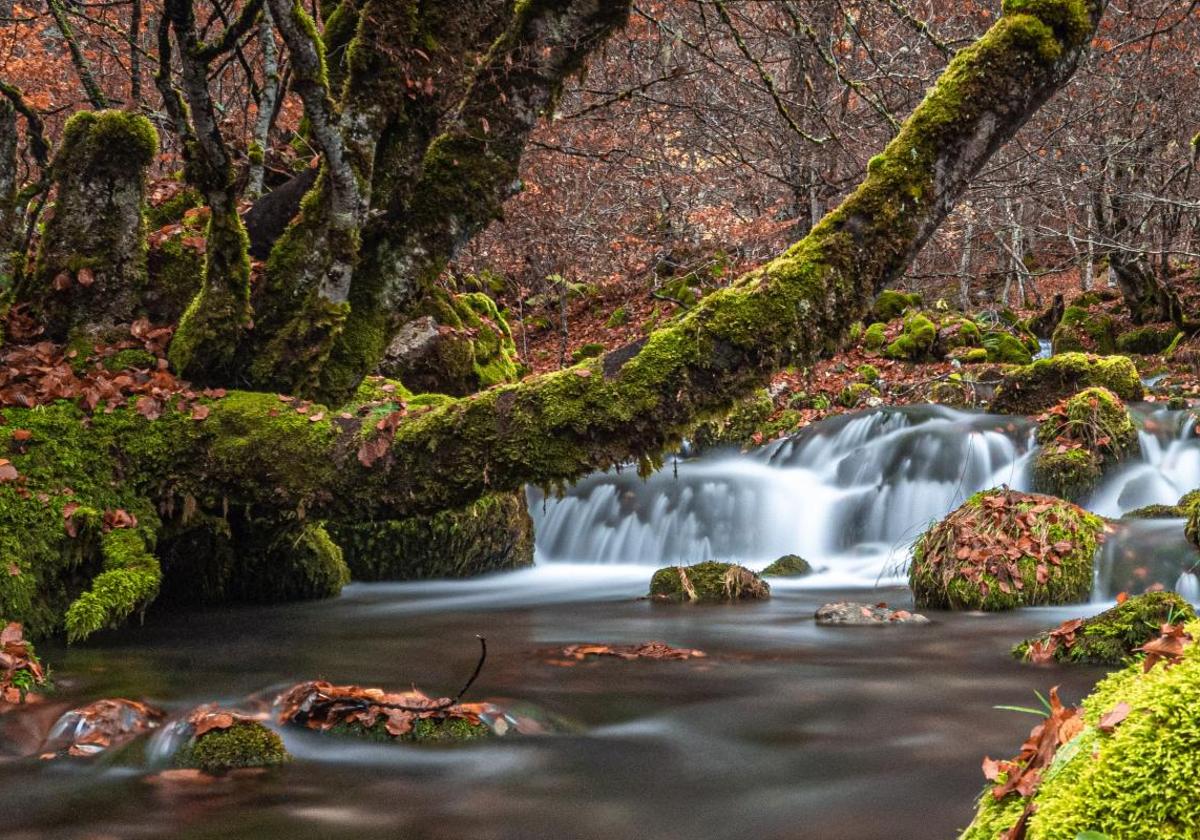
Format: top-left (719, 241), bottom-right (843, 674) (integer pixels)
top-left (991, 353), bottom-right (1145, 414)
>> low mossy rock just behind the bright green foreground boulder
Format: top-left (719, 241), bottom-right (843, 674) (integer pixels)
top-left (1013, 592), bottom-right (1196, 665)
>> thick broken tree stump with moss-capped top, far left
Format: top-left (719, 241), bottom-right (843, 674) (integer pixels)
top-left (16, 110), bottom-right (158, 340)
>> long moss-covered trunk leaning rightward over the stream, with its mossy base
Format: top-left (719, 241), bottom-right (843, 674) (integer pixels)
top-left (0, 0), bottom-right (1102, 634)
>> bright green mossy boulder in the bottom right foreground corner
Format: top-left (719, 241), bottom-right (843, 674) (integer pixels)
top-left (960, 623), bottom-right (1200, 840)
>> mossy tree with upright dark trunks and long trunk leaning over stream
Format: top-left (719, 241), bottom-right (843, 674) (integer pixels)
top-left (0, 0), bottom-right (1103, 636)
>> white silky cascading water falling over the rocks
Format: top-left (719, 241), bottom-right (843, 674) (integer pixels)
top-left (529, 406), bottom-right (1200, 596)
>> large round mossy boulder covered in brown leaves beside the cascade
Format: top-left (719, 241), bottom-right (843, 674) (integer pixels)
top-left (908, 488), bottom-right (1104, 611)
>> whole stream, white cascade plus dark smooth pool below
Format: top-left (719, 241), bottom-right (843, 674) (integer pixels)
top-left (0, 407), bottom-right (1200, 840)
